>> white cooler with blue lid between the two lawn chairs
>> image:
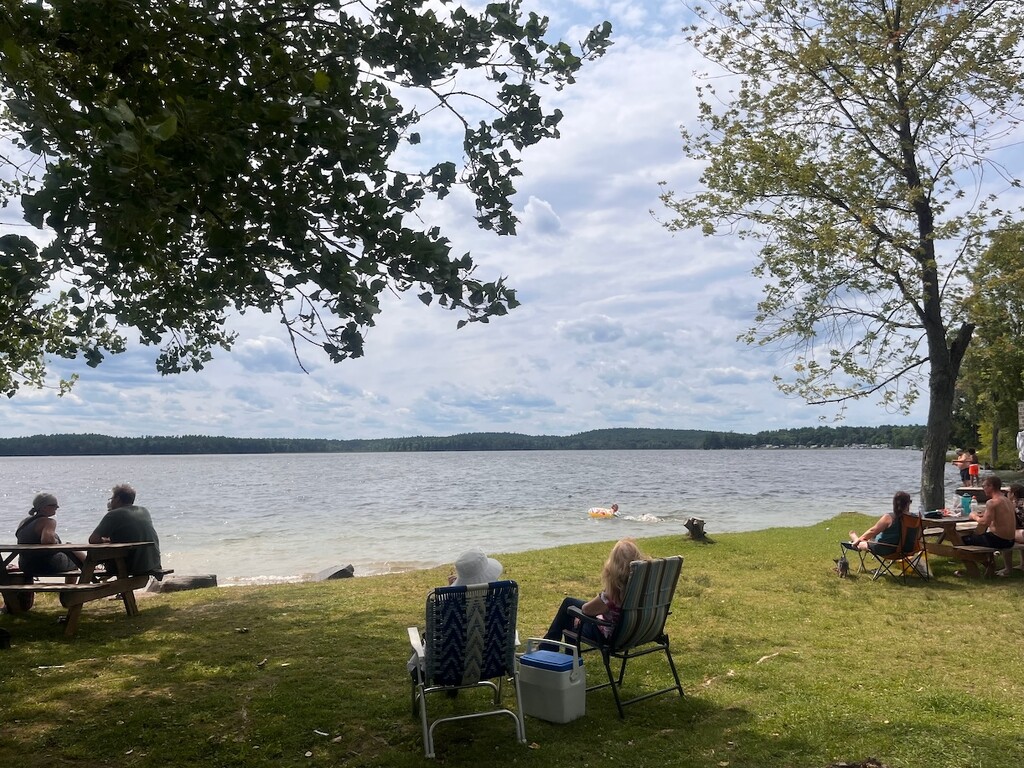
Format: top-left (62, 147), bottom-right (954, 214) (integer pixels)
top-left (516, 637), bottom-right (587, 723)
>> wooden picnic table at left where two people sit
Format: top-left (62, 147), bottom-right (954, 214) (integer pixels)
top-left (0, 542), bottom-right (173, 637)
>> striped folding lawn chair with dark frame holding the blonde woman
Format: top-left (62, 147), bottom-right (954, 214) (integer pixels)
top-left (565, 555), bottom-right (683, 718)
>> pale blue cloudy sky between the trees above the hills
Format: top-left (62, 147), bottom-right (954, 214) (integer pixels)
top-left (0, 0), bottom-right (926, 439)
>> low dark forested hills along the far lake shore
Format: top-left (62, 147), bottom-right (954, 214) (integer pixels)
top-left (0, 426), bottom-right (925, 456)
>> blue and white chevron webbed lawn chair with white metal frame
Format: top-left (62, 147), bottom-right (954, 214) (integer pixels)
top-left (409, 581), bottom-right (526, 758)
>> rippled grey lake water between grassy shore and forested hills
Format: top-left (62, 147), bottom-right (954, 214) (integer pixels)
top-left (0, 449), bottom-right (957, 585)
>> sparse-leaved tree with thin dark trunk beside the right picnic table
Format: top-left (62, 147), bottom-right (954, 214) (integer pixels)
top-left (663, 0), bottom-right (1024, 509)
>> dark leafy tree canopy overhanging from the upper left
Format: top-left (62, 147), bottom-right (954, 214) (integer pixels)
top-left (0, 0), bottom-right (610, 396)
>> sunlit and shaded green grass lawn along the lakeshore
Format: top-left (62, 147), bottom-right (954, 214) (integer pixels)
top-left (0, 515), bottom-right (1024, 768)
